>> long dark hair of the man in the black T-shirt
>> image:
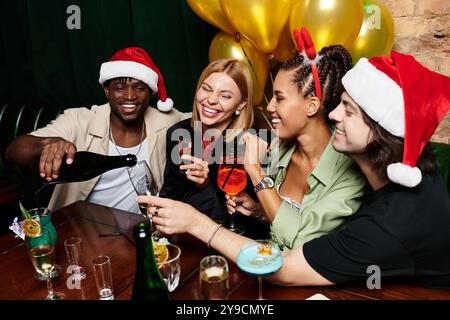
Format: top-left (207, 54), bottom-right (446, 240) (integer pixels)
top-left (361, 110), bottom-right (436, 179)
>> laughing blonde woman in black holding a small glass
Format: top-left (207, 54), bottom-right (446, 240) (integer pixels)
top-left (160, 59), bottom-right (253, 223)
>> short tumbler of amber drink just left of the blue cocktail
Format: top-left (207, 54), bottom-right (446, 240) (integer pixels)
top-left (200, 255), bottom-right (229, 300)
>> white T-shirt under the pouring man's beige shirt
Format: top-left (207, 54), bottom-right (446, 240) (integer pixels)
top-left (87, 138), bottom-right (148, 213)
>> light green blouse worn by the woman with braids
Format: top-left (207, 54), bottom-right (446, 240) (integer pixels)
top-left (270, 132), bottom-right (366, 249)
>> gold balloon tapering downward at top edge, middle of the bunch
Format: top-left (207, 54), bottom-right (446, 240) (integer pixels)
top-left (220, 0), bottom-right (291, 53)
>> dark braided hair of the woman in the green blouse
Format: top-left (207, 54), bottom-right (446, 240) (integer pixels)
top-left (280, 45), bottom-right (353, 123)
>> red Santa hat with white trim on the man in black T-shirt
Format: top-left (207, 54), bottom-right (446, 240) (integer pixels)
top-left (342, 51), bottom-right (450, 187)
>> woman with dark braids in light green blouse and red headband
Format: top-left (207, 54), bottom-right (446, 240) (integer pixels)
top-left (227, 45), bottom-right (365, 249)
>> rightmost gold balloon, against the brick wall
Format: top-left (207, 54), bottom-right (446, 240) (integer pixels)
top-left (350, 0), bottom-right (395, 64)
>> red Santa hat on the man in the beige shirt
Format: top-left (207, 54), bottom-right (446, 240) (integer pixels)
top-left (98, 47), bottom-right (173, 112)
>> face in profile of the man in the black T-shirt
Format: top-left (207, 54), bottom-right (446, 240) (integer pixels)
top-left (329, 92), bottom-right (373, 155)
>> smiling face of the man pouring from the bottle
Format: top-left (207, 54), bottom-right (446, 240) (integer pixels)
top-left (104, 78), bottom-right (151, 124)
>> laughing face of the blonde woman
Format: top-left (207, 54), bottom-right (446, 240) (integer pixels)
top-left (195, 72), bottom-right (245, 131)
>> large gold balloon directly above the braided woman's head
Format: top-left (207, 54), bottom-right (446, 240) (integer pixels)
top-left (289, 0), bottom-right (364, 51)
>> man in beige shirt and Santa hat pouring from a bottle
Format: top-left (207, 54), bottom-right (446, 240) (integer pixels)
top-left (7, 47), bottom-right (189, 212)
